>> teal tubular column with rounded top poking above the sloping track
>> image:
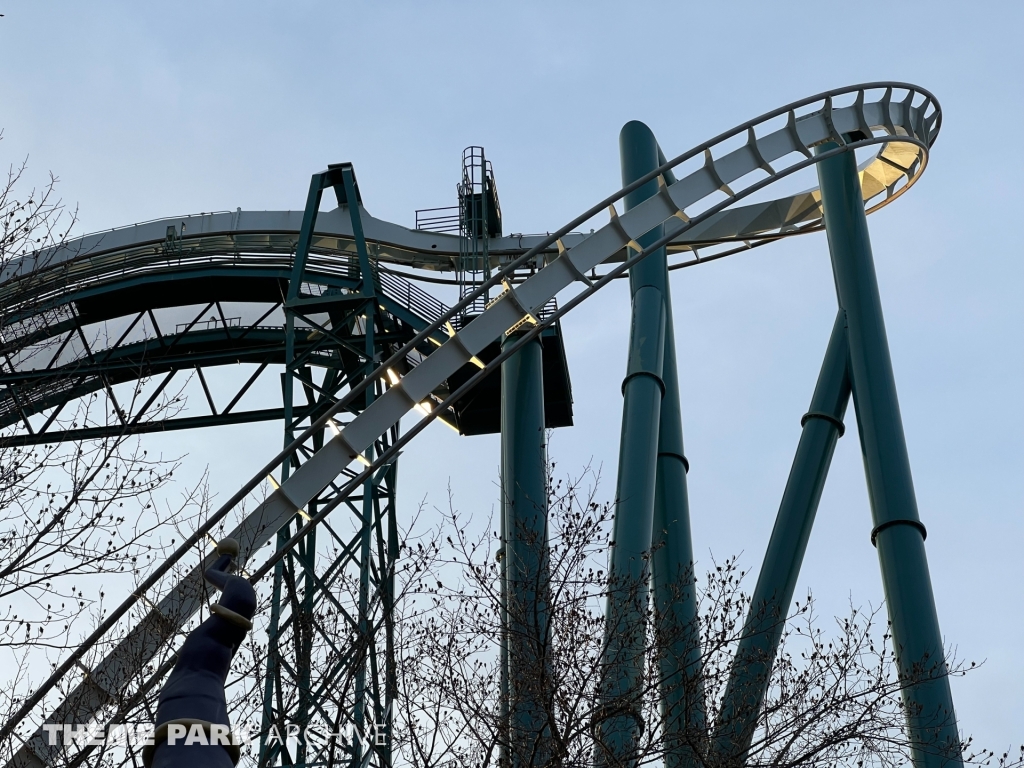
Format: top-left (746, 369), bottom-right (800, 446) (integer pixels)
top-left (594, 122), bottom-right (666, 767)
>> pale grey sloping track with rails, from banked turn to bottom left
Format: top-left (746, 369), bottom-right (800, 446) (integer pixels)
top-left (0, 83), bottom-right (941, 766)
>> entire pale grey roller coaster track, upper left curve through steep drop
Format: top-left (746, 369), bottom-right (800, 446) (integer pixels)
top-left (0, 83), bottom-right (941, 766)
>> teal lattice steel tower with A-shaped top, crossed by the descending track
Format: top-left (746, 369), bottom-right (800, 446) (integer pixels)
top-left (259, 164), bottom-right (397, 768)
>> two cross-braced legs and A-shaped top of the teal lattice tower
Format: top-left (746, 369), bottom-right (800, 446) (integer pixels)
top-left (260, 163), bottom-right (398, 768)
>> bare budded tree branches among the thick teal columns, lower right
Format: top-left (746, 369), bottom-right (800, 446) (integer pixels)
top-left (394, 462), bottom-right (1024, 768)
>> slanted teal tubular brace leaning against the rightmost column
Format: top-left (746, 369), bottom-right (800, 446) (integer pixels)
top-left (713, 309), bottom-right (850, 766)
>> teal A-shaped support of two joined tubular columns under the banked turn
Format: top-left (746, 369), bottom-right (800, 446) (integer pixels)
top-left (712, 142), bottom-right (963, 768)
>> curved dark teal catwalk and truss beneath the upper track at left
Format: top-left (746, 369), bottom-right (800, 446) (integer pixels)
top-left (0, 252), bottom-right (449, 444)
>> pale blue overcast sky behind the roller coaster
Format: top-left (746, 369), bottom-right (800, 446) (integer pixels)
top-left (0, 0), bottom-right (1024, 749)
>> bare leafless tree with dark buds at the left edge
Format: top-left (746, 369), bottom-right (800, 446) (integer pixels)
top-left (0, 140), bottom-right (206, 762)
